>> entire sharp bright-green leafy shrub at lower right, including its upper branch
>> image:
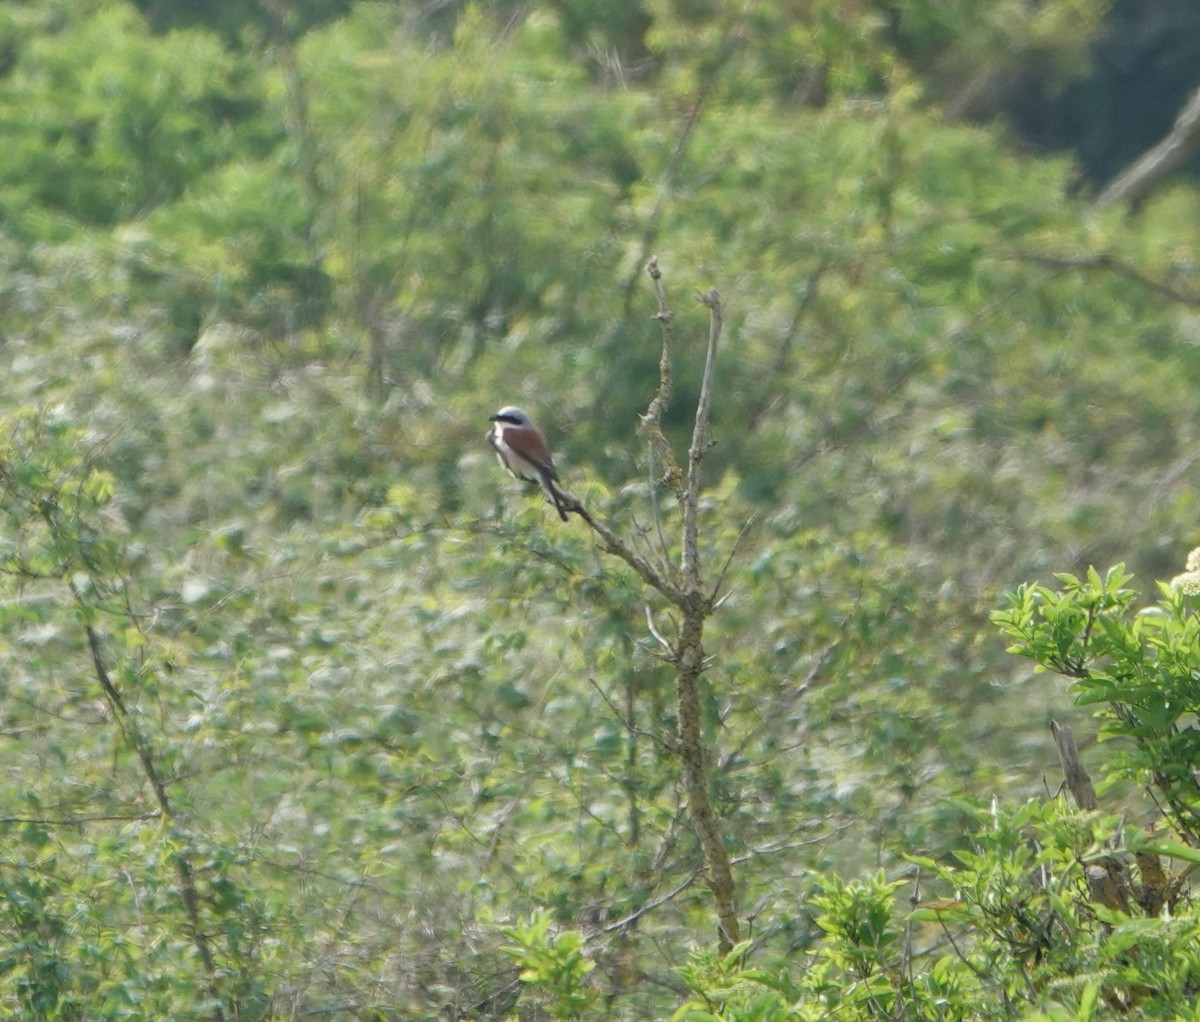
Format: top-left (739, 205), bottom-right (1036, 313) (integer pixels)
top-left (676, 554), bottom-right (1200, 1022)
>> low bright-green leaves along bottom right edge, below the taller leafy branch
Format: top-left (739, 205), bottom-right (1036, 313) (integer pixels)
top-left (674, 767), bottom-right (1200, 1022)
